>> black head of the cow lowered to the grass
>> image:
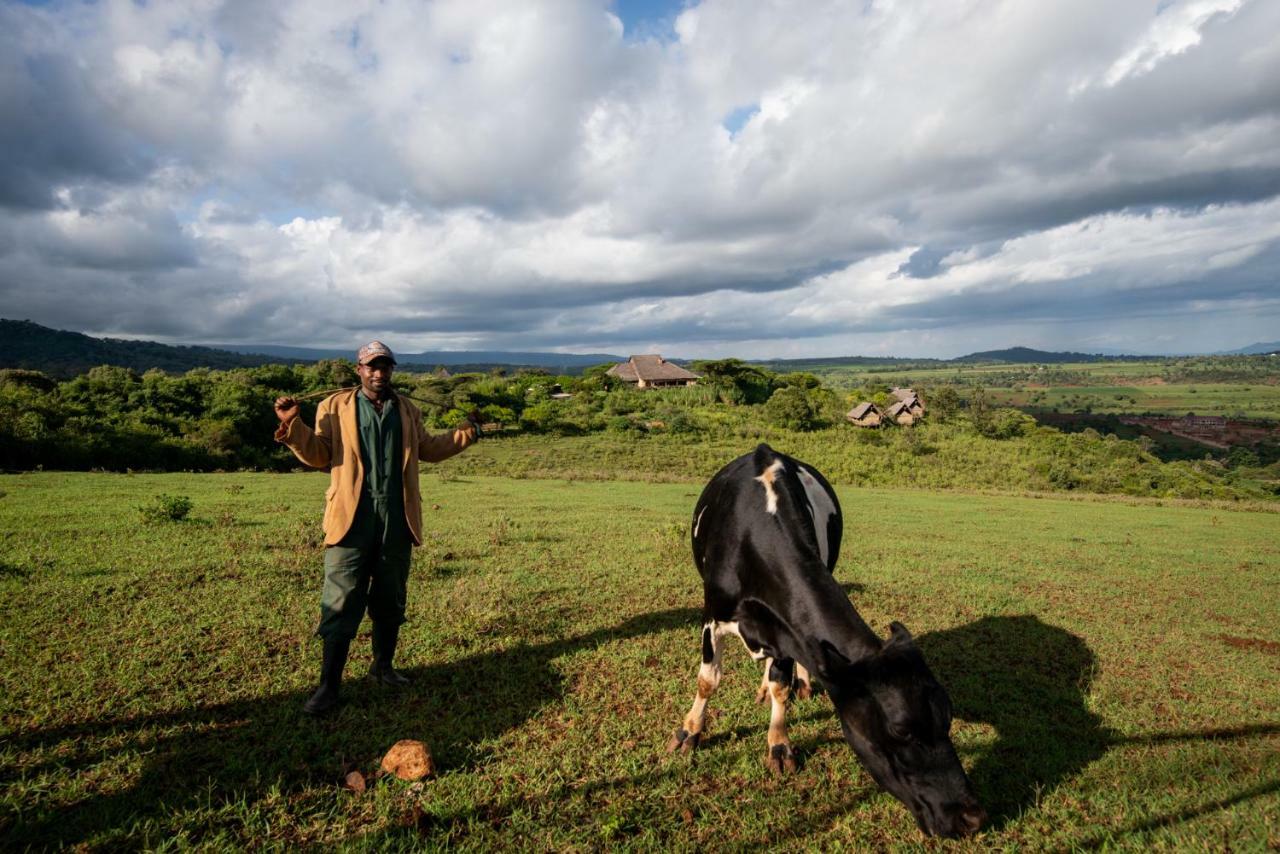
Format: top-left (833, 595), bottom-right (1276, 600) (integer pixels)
top-left (818, 622), bottom-right (986, 836)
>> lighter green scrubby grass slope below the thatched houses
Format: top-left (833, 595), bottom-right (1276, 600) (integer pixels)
top-left (451, 423), bottom-right (1280, 510)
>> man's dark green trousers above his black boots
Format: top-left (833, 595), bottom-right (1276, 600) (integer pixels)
top-left (316, 493), bottom-right (413, 640)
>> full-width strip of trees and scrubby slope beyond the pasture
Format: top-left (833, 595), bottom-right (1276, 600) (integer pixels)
top-left (0, 360), bottom-right (1275, 504)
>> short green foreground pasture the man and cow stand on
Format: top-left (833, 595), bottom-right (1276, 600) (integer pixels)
top-left (0, 471), bottom-right (1280, 850)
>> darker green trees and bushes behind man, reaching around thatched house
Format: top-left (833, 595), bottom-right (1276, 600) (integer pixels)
top-left (0, 359), bottom-right (1007, 470)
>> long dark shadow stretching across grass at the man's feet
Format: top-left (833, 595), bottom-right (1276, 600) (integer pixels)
top-left (0, 608), bottom-right (699, 848)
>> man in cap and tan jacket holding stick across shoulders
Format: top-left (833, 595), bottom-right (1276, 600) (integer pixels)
top-left (275, 341), bottom-right (480, 714)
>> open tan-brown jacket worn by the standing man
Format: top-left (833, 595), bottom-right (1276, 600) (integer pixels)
top-left (275, 388), bottom-right (476, 545)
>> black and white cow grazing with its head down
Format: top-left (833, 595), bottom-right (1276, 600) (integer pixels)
top-left (668, 444), bottom-right (986, 836)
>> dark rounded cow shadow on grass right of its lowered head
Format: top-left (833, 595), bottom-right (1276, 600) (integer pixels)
top-left (916, 615), bottom-right (1114, 828)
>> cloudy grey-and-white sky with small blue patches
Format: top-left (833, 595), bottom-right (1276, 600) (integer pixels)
top-left (0, 0), bottom-right (1280, 359)
